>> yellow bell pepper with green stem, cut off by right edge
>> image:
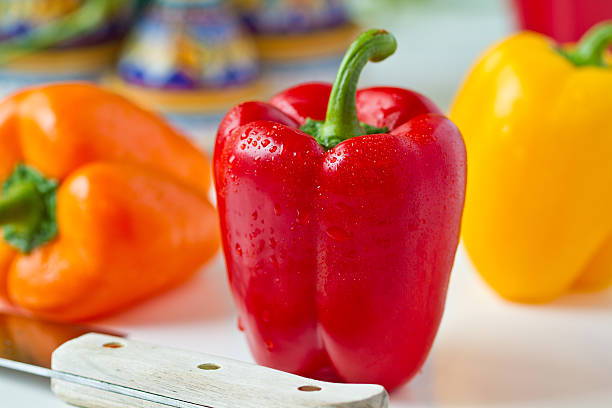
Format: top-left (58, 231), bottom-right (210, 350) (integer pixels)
top-left (451, 24), bottom-right (612, 302)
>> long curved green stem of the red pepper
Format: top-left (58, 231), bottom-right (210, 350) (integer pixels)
top-left (315, 29), bottom-right (397, 149)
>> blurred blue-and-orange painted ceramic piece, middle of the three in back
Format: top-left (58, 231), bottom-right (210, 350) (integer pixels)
top-left (111, 0), bottom-right (259, 112)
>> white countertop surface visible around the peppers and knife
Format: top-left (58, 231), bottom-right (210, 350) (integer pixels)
top-left (0, 245), bottom-right (612, 408)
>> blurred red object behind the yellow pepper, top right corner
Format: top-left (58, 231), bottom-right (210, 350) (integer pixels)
top-left (513, 0), bottom-right (612, 43)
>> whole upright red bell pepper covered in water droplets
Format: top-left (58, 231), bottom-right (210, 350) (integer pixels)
top-left (213, 30), bottom-right (466, 390)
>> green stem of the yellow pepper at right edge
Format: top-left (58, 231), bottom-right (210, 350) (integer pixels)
top-left (560, 22), bottom-right (612, 67)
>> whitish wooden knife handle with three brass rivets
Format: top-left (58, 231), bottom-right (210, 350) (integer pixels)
top-left (52, 333), bottom-right (388, 408)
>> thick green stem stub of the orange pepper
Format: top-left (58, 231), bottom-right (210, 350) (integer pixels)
top-left (0, 182), bottom-right (45, 230)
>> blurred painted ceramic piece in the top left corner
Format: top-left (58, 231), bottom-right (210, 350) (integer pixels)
top-left (0, 0), bottom-right (139, 77)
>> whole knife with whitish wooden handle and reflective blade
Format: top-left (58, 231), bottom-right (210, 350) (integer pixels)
top-left (0, 313), bottom-right (388, 408)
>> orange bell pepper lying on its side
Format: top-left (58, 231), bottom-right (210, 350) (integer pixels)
top-left (0, 83), bottom-right (219, 321)
